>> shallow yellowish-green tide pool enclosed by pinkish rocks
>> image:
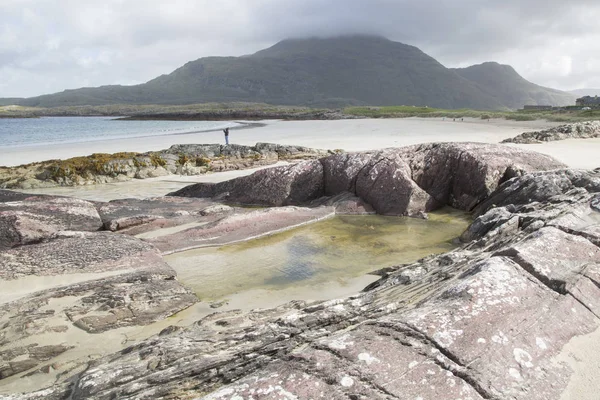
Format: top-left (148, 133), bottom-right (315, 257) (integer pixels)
top-left (166, 209), bottom-right (470, 300)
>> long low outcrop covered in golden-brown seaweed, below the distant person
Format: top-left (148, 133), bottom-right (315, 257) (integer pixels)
top-left (0, 143), bottom-right (329, 189)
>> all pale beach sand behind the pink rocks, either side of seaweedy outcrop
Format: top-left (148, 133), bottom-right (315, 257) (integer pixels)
top-left (5, 118), bottom-right (600, 201)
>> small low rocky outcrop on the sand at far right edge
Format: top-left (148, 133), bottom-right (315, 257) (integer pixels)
top-left (502, 121), bottom-right (600, 144)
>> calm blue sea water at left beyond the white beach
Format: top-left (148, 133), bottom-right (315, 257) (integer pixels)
top-left (0, 117), bottom-right (239, 147)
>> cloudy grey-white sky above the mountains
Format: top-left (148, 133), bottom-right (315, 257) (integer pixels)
top-left (0, 0), bottom-right (600, 97)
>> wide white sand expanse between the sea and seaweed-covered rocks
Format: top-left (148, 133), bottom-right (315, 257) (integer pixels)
top-left (0, 118), bottom-right (568, 166)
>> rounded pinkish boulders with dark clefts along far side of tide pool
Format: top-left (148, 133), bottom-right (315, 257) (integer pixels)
top-left (170, 143), bottom-right (564, 215)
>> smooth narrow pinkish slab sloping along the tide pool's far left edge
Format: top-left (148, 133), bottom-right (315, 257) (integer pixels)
top-left (146, 206), bottom-right (335, 254)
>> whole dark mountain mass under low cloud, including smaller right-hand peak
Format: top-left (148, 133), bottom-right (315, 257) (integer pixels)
top-left (19, 36), bottom-right (569, 109)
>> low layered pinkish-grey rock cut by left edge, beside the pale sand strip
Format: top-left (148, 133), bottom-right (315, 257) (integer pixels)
top-left (0, 190), bottom-right (102, 250)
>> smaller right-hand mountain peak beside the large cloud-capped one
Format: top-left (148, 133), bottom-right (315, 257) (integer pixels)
top-left (453, 62), bottom-right (575, 108)
